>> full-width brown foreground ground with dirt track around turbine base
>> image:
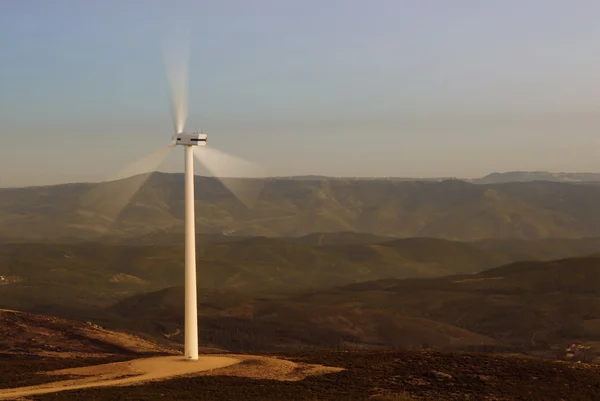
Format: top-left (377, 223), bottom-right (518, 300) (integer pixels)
top-left (0, 311), bottom-right (600, 400)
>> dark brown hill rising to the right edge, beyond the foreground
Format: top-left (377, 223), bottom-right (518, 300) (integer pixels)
top-left (294, 256), bottom-right (600, 349)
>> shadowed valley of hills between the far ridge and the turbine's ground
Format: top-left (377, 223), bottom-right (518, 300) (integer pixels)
top-left (0, 232), bottom-right (600, 358)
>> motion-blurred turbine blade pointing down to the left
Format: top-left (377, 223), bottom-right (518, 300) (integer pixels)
top-left (82, 145), bottom-right (173, 228)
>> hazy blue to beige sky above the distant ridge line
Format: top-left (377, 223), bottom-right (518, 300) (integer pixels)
top-left (0, 0), bottom-right (600, 186)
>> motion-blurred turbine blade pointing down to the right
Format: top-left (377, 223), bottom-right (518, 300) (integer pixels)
top-left (195, 146), bottom-right (266, 208)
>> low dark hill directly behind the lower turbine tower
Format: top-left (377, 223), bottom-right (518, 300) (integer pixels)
top-left (107, 287), bottom-right (496, 352)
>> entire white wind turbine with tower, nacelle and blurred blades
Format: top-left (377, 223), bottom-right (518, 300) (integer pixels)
top-left (89, 28), bottom-right (264, 360)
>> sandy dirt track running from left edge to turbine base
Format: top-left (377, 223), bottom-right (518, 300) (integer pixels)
top-left (0, 356), bottom-right (240, 400)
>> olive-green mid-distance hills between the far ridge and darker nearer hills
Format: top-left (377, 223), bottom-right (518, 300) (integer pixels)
top-left (5, 233), bottom-right (600, 314)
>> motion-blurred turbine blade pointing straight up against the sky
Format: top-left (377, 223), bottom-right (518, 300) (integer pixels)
top-left (163, 26), bottom-right (190, 134)
